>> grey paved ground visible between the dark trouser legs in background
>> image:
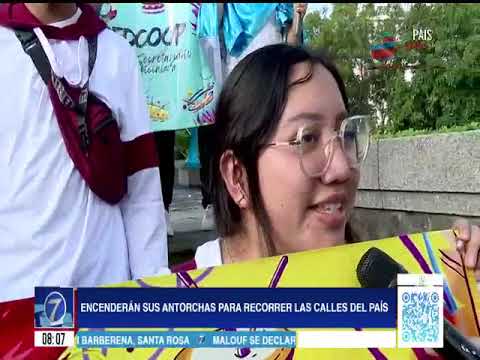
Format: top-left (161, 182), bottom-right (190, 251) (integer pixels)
top-left (168, 186), bottom-right (216, 265)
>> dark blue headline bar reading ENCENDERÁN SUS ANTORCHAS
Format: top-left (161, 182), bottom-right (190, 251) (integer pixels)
top-left (76, 288), bottom-right (397, 329)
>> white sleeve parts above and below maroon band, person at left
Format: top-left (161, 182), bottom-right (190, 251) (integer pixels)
top-left (119, 48), bottom-right (169, 279)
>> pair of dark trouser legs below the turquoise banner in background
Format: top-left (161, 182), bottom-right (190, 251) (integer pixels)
top-left (155, 125), bottom-right (213, 211)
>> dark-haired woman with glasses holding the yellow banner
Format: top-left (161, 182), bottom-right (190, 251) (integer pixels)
top-left (174, 44), bottom-right (480, 271)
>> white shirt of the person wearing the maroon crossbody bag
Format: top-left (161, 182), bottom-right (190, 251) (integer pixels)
top-left (0, 10), bottom-right (169, 301)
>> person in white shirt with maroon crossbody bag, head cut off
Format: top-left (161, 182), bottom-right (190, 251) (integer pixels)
top-left (0, 3), bottom-right (169, 359)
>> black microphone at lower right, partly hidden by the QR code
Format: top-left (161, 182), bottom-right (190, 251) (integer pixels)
top-left (357, 247), bottom-right (480, 360)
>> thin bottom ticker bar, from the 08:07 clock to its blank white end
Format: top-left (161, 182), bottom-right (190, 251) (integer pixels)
top-left (35, 329), bottom-right (397, 349)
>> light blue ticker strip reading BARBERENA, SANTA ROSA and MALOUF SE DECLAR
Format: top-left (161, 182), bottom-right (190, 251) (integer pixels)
top-left (77, 331), bottom-right (296, 349)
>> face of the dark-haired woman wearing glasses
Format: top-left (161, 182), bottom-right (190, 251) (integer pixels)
top-left (258, 63), bottom-right (359, 253)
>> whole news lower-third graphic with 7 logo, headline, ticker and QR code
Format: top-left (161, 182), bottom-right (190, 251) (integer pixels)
top-left (35, 274), bottom-right (443, 348)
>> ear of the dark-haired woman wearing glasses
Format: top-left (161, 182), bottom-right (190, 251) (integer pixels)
top-left (220, 150), bottom-right (249, 209)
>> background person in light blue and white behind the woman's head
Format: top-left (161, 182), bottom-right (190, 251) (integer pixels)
top-left (193, 3), bottom-right (307, 230)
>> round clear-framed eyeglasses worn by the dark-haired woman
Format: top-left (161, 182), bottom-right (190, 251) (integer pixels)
top-left (267, 115), bottom-right (371, 177)
